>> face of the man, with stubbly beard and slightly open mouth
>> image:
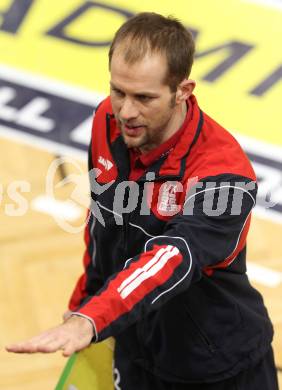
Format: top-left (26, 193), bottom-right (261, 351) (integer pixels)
top-left (110, 48), bottom-right (178, 152)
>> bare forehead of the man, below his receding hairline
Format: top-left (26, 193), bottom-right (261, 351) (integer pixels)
top-left (110, 51), bottom-right (168, 92)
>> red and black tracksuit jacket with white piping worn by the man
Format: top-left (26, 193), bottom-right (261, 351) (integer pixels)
top-left (67, 96), bottom-right (273, 383)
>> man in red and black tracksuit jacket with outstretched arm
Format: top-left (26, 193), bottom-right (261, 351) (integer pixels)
top-left (7, 13), bottom-right (278, 390)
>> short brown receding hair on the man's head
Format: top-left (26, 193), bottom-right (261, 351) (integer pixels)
top-left (109, 12), bottom-right (195, 92)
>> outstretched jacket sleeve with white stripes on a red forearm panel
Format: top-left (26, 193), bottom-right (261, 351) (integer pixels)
top-left (72, 175), bottom-right (256, 341)
